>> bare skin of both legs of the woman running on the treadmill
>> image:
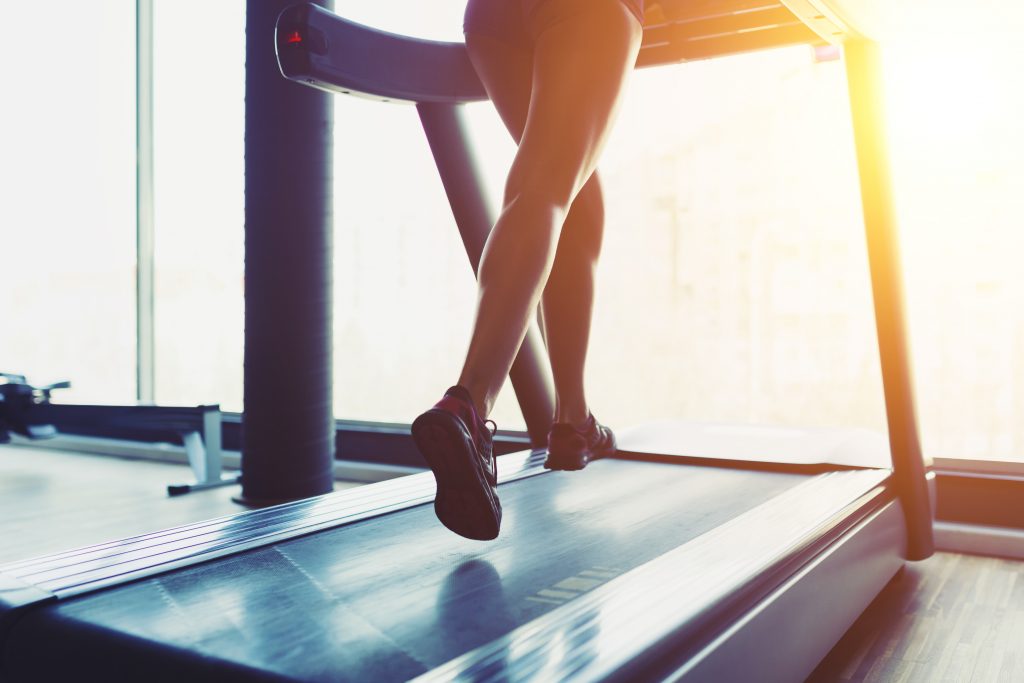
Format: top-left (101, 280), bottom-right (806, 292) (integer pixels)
top-left (459, 2), bottom-right (641, 424)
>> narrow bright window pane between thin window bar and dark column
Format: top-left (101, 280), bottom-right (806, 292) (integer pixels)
top-left (154, 0), bottom-right (245, 411)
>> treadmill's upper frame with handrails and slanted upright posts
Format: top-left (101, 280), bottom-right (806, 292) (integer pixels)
top-left (274, 0), bottom-right (934, 560)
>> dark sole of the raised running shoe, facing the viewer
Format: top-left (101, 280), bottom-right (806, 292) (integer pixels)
top-left (413, 409), bottom-right (502, 541)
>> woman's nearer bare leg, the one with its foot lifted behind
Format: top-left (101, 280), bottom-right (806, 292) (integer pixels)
top-left (459, 0), bottom-right (641, 415)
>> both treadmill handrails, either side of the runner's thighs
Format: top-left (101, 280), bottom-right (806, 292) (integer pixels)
top-left (274, 0), bottom-right (823, 103)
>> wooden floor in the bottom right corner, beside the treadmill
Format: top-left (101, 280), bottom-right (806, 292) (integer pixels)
top-left (808, 553), bottom-right (1024, 683)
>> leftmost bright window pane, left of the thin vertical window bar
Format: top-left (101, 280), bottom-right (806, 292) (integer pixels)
top-left (0, 0), bottom-right (135, 403)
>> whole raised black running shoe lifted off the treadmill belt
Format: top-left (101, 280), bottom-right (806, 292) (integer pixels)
top-left (413, 386), bottom-right (502, 541)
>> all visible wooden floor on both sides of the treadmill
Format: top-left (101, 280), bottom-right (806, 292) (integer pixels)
top-left (0, 445), bottom-right (1024, 683)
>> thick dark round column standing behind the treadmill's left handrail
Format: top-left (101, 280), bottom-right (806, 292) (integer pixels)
top-left (241, 0), bottom-right (334, 504)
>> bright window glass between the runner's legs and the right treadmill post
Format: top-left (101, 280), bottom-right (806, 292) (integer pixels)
top-left (589, 47), bottom-right (885, 428)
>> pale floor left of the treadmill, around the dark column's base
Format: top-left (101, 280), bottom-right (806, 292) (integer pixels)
top-left (0, 444), bottom-right (357, 564)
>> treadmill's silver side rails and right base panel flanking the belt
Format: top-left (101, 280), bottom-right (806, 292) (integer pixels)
top-left (0, 451), bottom-right (906, 681)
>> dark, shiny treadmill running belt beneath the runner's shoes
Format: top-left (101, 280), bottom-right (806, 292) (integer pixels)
top-left (8, 460), bottom-right (807, 681)
